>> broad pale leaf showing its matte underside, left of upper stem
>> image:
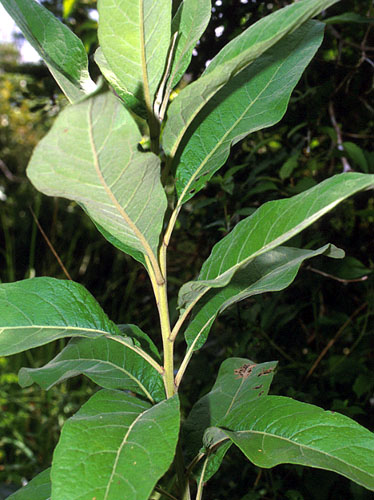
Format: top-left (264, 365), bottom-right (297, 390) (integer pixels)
top-left (27, 93), bottom-right (166, 268)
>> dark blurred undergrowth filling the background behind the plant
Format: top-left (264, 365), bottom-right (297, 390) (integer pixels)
top-left (0, 0), bottom-right (374, 500)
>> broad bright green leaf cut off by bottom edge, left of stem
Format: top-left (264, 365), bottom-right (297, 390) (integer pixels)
top-left (51, 390), bottom-right (179, 500)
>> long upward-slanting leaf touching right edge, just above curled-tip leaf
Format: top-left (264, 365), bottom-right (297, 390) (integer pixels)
top-left (180, 172), bottom-right (374, 316)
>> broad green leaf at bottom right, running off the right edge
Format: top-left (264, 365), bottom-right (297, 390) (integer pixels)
top-left (215, 396), bottom-right (374, 490)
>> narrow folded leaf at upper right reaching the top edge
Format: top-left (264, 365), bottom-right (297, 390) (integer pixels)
top-left (163, 0), bottom-right (339, 157)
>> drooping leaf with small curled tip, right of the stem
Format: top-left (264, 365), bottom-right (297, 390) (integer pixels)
top-left (183, 245), bottom-right (344, 350)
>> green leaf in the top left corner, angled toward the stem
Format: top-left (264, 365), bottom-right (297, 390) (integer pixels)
top-left (1, 0), bottom-right (96, 102)
